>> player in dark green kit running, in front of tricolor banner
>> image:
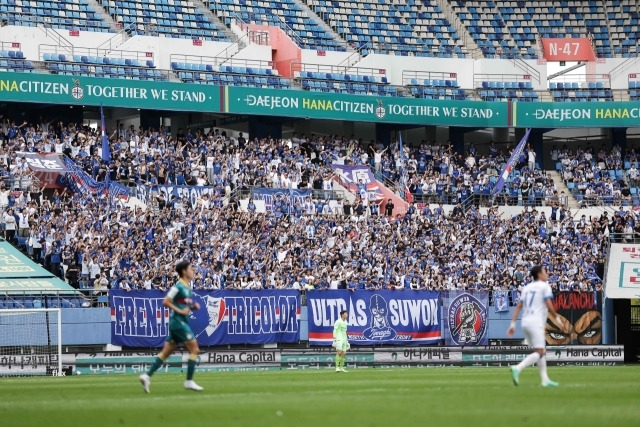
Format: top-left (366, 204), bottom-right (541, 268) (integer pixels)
top-left (140, 261), bottom-right (203, 393)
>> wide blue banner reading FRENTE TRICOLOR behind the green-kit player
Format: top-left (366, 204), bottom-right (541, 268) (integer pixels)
top-left (109, 290), bottom-right (301, 347)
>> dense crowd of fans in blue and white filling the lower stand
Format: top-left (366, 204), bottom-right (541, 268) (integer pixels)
top-left (0, 115), bottom-right (640, 300)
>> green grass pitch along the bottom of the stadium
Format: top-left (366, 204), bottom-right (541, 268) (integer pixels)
top-left (0, 366), bottom-right (640, 427)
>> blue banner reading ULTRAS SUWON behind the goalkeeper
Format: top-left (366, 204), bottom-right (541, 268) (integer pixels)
top-left (307, 290), bottom-right (442, 346)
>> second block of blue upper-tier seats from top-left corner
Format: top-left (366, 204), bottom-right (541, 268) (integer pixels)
top-left (102, 0), bottom-right (230, 41)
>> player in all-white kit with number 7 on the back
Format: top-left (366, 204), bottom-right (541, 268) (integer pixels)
top-left (507, 265), bottom-right (561, 387)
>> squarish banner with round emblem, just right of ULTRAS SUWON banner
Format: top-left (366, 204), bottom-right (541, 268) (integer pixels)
top-left (442, 291), bottom-right (489, 346)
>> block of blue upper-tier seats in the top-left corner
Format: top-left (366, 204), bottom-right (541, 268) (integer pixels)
top-left (0, 0), bottom-right (110, 32)
